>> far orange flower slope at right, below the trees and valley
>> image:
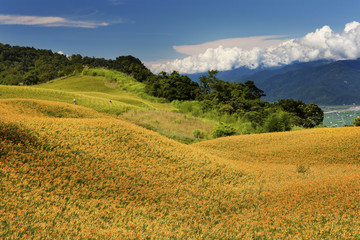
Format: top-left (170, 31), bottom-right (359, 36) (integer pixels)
top-left (194, 127), bottom-right (360, 166)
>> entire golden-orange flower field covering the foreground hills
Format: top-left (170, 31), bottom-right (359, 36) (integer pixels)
top-left (0, 99), bottom-right (360, 239)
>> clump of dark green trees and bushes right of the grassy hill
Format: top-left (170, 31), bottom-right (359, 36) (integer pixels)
top-left (145, 70), bottom-right (324, 132)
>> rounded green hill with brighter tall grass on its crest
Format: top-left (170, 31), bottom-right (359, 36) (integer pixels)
top-left (0, 69), bottom-right (173, 115)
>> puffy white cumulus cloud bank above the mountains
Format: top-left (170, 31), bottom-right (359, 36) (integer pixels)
top-left (148, 21), bottom-right (360, 73)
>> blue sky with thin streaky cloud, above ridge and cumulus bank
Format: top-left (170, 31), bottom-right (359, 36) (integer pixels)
top-left (0, 0), bottom-right (360, 72)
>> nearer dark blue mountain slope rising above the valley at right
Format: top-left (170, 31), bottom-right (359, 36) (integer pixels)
top-left (255, 60), bottom-right (360, 105)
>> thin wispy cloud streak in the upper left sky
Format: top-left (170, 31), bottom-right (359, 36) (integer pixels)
top-left (0, 14), bottom-right (109, 28)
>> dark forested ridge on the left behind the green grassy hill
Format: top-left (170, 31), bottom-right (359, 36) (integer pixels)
top-left (0, 44), bottom-right (153, 85)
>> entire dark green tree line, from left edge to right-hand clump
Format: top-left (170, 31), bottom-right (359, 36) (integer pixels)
top-left (0, 44), bottom-right (324, 132)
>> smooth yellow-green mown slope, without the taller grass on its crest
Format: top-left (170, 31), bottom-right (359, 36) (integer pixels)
top-left (0, 72), bottom-right (172, 115)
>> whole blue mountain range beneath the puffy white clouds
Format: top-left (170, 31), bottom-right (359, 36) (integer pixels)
top-left (189, 58), bottom-right (360, 105)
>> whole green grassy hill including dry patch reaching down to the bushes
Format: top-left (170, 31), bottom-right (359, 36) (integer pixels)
top-left (0, 69), bottom-right (215, 143)
